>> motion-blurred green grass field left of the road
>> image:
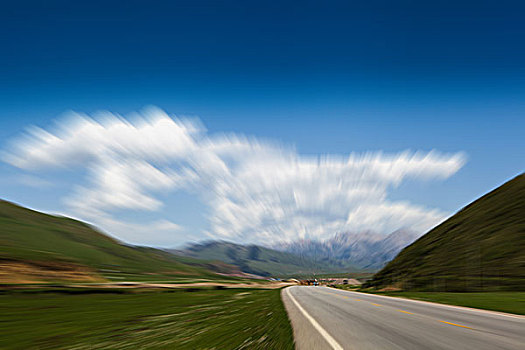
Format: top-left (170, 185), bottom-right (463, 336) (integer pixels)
top-left (0, 289), bottom-right (294, 350)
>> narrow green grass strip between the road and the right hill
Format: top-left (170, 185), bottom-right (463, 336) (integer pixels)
top-left (357, 290), bottom-right (525, 315)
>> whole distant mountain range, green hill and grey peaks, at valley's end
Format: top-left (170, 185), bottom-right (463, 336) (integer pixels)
top-left (174, 230), bottom-right (418, 276)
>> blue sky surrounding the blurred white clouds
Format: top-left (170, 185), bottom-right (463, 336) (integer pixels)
top-left (0, 1), bottom-right (525, 246)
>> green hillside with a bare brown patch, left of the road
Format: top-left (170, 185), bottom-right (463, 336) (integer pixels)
top-left (0, 200), bottom-right (229, 283)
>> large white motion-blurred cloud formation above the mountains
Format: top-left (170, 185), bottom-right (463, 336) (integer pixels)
top-left (3, 108), bottom-right (465, 244)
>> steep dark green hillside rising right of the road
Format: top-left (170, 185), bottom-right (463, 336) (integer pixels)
top-left (366, 174), bottom-right (525, 291)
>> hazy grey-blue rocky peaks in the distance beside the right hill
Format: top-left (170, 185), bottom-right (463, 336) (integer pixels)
top-left (279, 230), bottom-right (418, 270)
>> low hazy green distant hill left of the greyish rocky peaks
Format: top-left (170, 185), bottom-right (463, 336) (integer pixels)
top-left (171, 241), bottom-right (355, 276)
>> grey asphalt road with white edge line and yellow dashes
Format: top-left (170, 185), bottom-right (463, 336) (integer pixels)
top-left (282, 286), bottom-right (525, 350)
